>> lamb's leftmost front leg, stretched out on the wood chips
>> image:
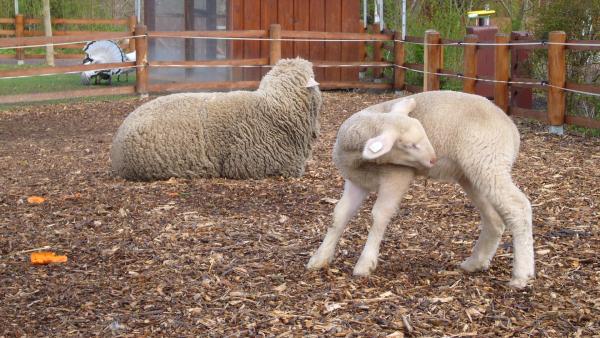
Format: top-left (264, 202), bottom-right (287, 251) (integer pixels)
top-left (306, 180), bottom-right (368, 270)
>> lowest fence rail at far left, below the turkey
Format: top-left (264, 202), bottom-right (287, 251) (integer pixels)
top-left (0, 86), bottom-right (135, 104)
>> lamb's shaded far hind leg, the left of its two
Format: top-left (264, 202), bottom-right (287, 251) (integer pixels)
top-left (460, 179), bottom-right (505, 272)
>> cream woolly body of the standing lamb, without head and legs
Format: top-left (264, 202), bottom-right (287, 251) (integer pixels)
top-left (333, 91), bottom-right (520, 190)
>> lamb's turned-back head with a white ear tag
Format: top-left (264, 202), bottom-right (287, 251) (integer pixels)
top-left (362, 98), bottom-right (436, 169)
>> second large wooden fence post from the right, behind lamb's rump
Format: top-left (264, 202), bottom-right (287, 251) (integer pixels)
top-left (494, 33), bottom-right (510, 114)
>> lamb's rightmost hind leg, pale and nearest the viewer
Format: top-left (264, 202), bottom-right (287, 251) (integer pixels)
top-left (477, 172), bottom-right (535, 288)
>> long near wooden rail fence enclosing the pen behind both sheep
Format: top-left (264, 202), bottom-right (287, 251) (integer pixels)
top-left (0, 24), bottom-right (600, 128)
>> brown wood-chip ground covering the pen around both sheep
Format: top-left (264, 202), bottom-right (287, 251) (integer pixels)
top-left (0, 93), bottom-right (600, 337)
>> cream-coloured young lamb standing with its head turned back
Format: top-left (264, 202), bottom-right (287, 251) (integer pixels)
top-left (307, 91), bottom-right (534, 288)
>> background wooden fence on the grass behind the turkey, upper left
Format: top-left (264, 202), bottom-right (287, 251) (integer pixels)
top-left (0, 14), bottom-right (137, 61)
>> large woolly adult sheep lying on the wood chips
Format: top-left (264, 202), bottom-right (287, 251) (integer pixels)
top-left (110, 58), bottom-right (322, 180)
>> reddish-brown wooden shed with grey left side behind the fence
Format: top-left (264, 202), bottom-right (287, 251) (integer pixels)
top-left (144, 0), bottom-right (362, 81)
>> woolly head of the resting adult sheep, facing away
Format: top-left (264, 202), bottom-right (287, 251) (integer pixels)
top-left (260, 57), bottom-right (319, 89)
